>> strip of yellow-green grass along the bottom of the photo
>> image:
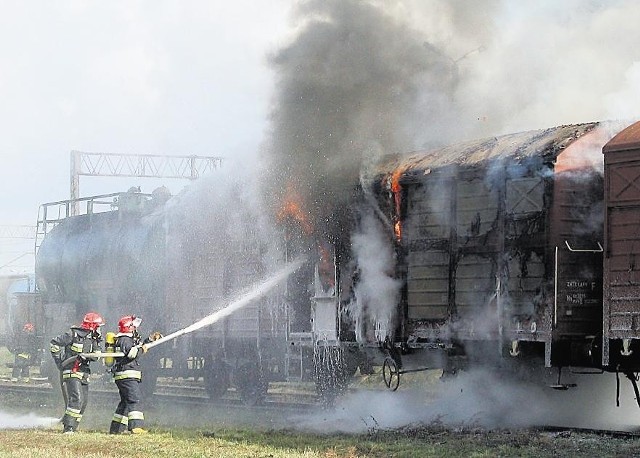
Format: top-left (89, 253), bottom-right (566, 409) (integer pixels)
top-left (0, 428), bottom-right (640, 458)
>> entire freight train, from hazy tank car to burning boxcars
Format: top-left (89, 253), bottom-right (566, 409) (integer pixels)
top-left (26, 119), bottom-right (640, 403)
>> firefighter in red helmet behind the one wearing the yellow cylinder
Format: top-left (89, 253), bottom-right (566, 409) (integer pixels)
top-left (51, 312), bottom-right (104, 433)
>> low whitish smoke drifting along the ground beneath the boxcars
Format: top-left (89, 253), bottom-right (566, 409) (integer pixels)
top-left (295, 370), bottom-right (640, 433)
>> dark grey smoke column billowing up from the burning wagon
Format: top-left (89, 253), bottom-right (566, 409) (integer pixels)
top-left (258, 0), bottom-right (484, 229)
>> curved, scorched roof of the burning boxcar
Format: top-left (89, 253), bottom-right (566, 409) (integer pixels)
top-left (380, 122), bottom-right (599, 173)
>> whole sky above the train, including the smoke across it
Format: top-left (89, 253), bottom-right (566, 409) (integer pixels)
top-left (0, 0), bottom-right (640, 271)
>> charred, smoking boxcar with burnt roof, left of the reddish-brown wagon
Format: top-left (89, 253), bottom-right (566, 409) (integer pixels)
top-left (368, 124), bottom-right (603, 376)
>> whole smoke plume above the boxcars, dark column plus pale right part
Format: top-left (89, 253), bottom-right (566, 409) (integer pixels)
top-left (264, 0), bottom-right (640, 223)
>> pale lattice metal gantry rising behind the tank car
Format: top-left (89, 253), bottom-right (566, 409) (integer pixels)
top-left (70, 151), bottom-right (223, 215)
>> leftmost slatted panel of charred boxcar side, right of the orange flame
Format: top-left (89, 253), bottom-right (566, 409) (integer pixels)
top-left (403, 173), bottom-right (453, 321)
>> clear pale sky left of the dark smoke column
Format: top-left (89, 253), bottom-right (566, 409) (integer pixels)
top-left (0, 0), bottom-right (287, 224)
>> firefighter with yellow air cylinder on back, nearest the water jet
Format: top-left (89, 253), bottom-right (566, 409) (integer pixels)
top-left (109, 315), bottom-right (162, 434)
